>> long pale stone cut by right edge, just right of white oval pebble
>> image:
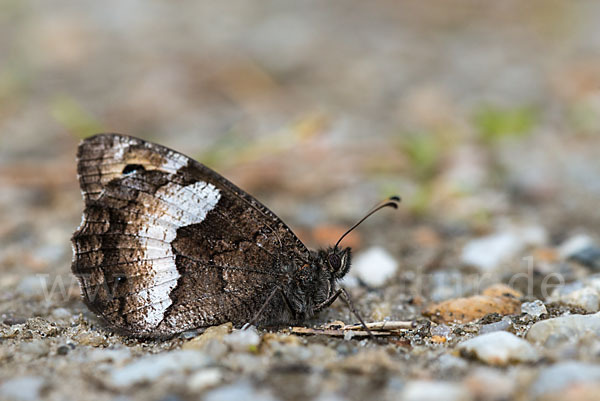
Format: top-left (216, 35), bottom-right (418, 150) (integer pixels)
top-left (527, 312), bottom-right (600, 346)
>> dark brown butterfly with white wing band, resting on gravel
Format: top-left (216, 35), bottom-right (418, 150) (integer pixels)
top-left (72, 134), bottom-right (400, 338)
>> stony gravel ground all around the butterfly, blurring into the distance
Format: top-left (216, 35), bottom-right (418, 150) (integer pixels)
top-left (0, 0), bottom-right (600, 401)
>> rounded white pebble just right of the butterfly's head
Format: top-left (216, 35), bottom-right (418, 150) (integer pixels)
top-left (350, 247), bottom-right (398, 287)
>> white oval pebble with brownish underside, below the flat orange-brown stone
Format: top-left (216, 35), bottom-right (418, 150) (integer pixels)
top-left (458, 331), bottom-right (539, 366)
